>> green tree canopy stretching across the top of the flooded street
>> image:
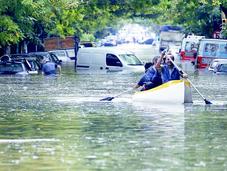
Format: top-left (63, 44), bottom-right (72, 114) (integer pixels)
top-left (0, 0), bottom-right (227, 47)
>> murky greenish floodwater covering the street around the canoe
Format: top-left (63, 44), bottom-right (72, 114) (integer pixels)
top-left (0, 45), bottom-right (227, 171)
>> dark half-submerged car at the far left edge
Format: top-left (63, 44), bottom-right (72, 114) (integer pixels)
top-left (0, 61), bottom-right (29, 76)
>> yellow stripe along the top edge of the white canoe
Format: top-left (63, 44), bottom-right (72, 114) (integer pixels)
top-left (136, 80), bottom-right (190, 94)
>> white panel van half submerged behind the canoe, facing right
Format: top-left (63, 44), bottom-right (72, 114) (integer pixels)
top-left (77, 47), bottom-right (144, 72)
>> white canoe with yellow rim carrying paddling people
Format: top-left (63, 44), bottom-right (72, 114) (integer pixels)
top-left (132, 80), bottom-right (192, 104)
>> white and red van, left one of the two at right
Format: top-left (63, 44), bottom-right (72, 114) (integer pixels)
top-left (180, 35), bottom-right (205, 61)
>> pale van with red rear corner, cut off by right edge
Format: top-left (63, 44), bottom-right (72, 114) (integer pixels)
top-left (196, 39), bottom-right (227, 68)
